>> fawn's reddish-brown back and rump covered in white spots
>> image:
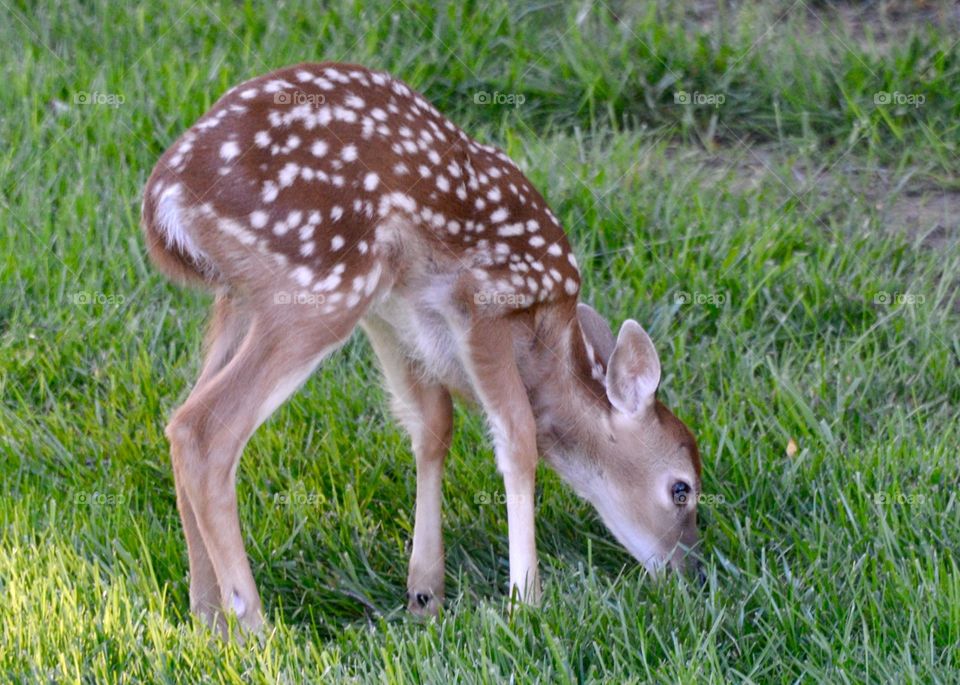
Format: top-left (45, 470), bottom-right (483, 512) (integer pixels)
top-left (144, 64), bottom-right (579, 320)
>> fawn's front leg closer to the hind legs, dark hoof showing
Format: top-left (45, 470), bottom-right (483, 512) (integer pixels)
top-left (363, 317), bottom-right (453, 616)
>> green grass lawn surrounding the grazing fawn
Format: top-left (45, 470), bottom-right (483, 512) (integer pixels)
top-left (0, 0), bottom-right (960, 683)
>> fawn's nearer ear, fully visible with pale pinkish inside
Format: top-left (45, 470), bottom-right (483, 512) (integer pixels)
top-left (607, 319), bottom-right (660, 415)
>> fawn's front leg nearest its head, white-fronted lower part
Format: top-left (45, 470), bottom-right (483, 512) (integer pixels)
top-left (461, 312), bottom-right (540, 604)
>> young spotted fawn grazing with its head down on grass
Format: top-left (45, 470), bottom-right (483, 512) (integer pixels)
top-left (142, 63), bottom-right (700, 630)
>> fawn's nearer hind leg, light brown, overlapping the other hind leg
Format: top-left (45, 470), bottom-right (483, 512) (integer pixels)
top-left (167, 302), bottom-right (362, 630)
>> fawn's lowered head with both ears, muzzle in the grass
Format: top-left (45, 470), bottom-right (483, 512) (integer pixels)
top-left (554, 304), bottom-right (700, 571)
